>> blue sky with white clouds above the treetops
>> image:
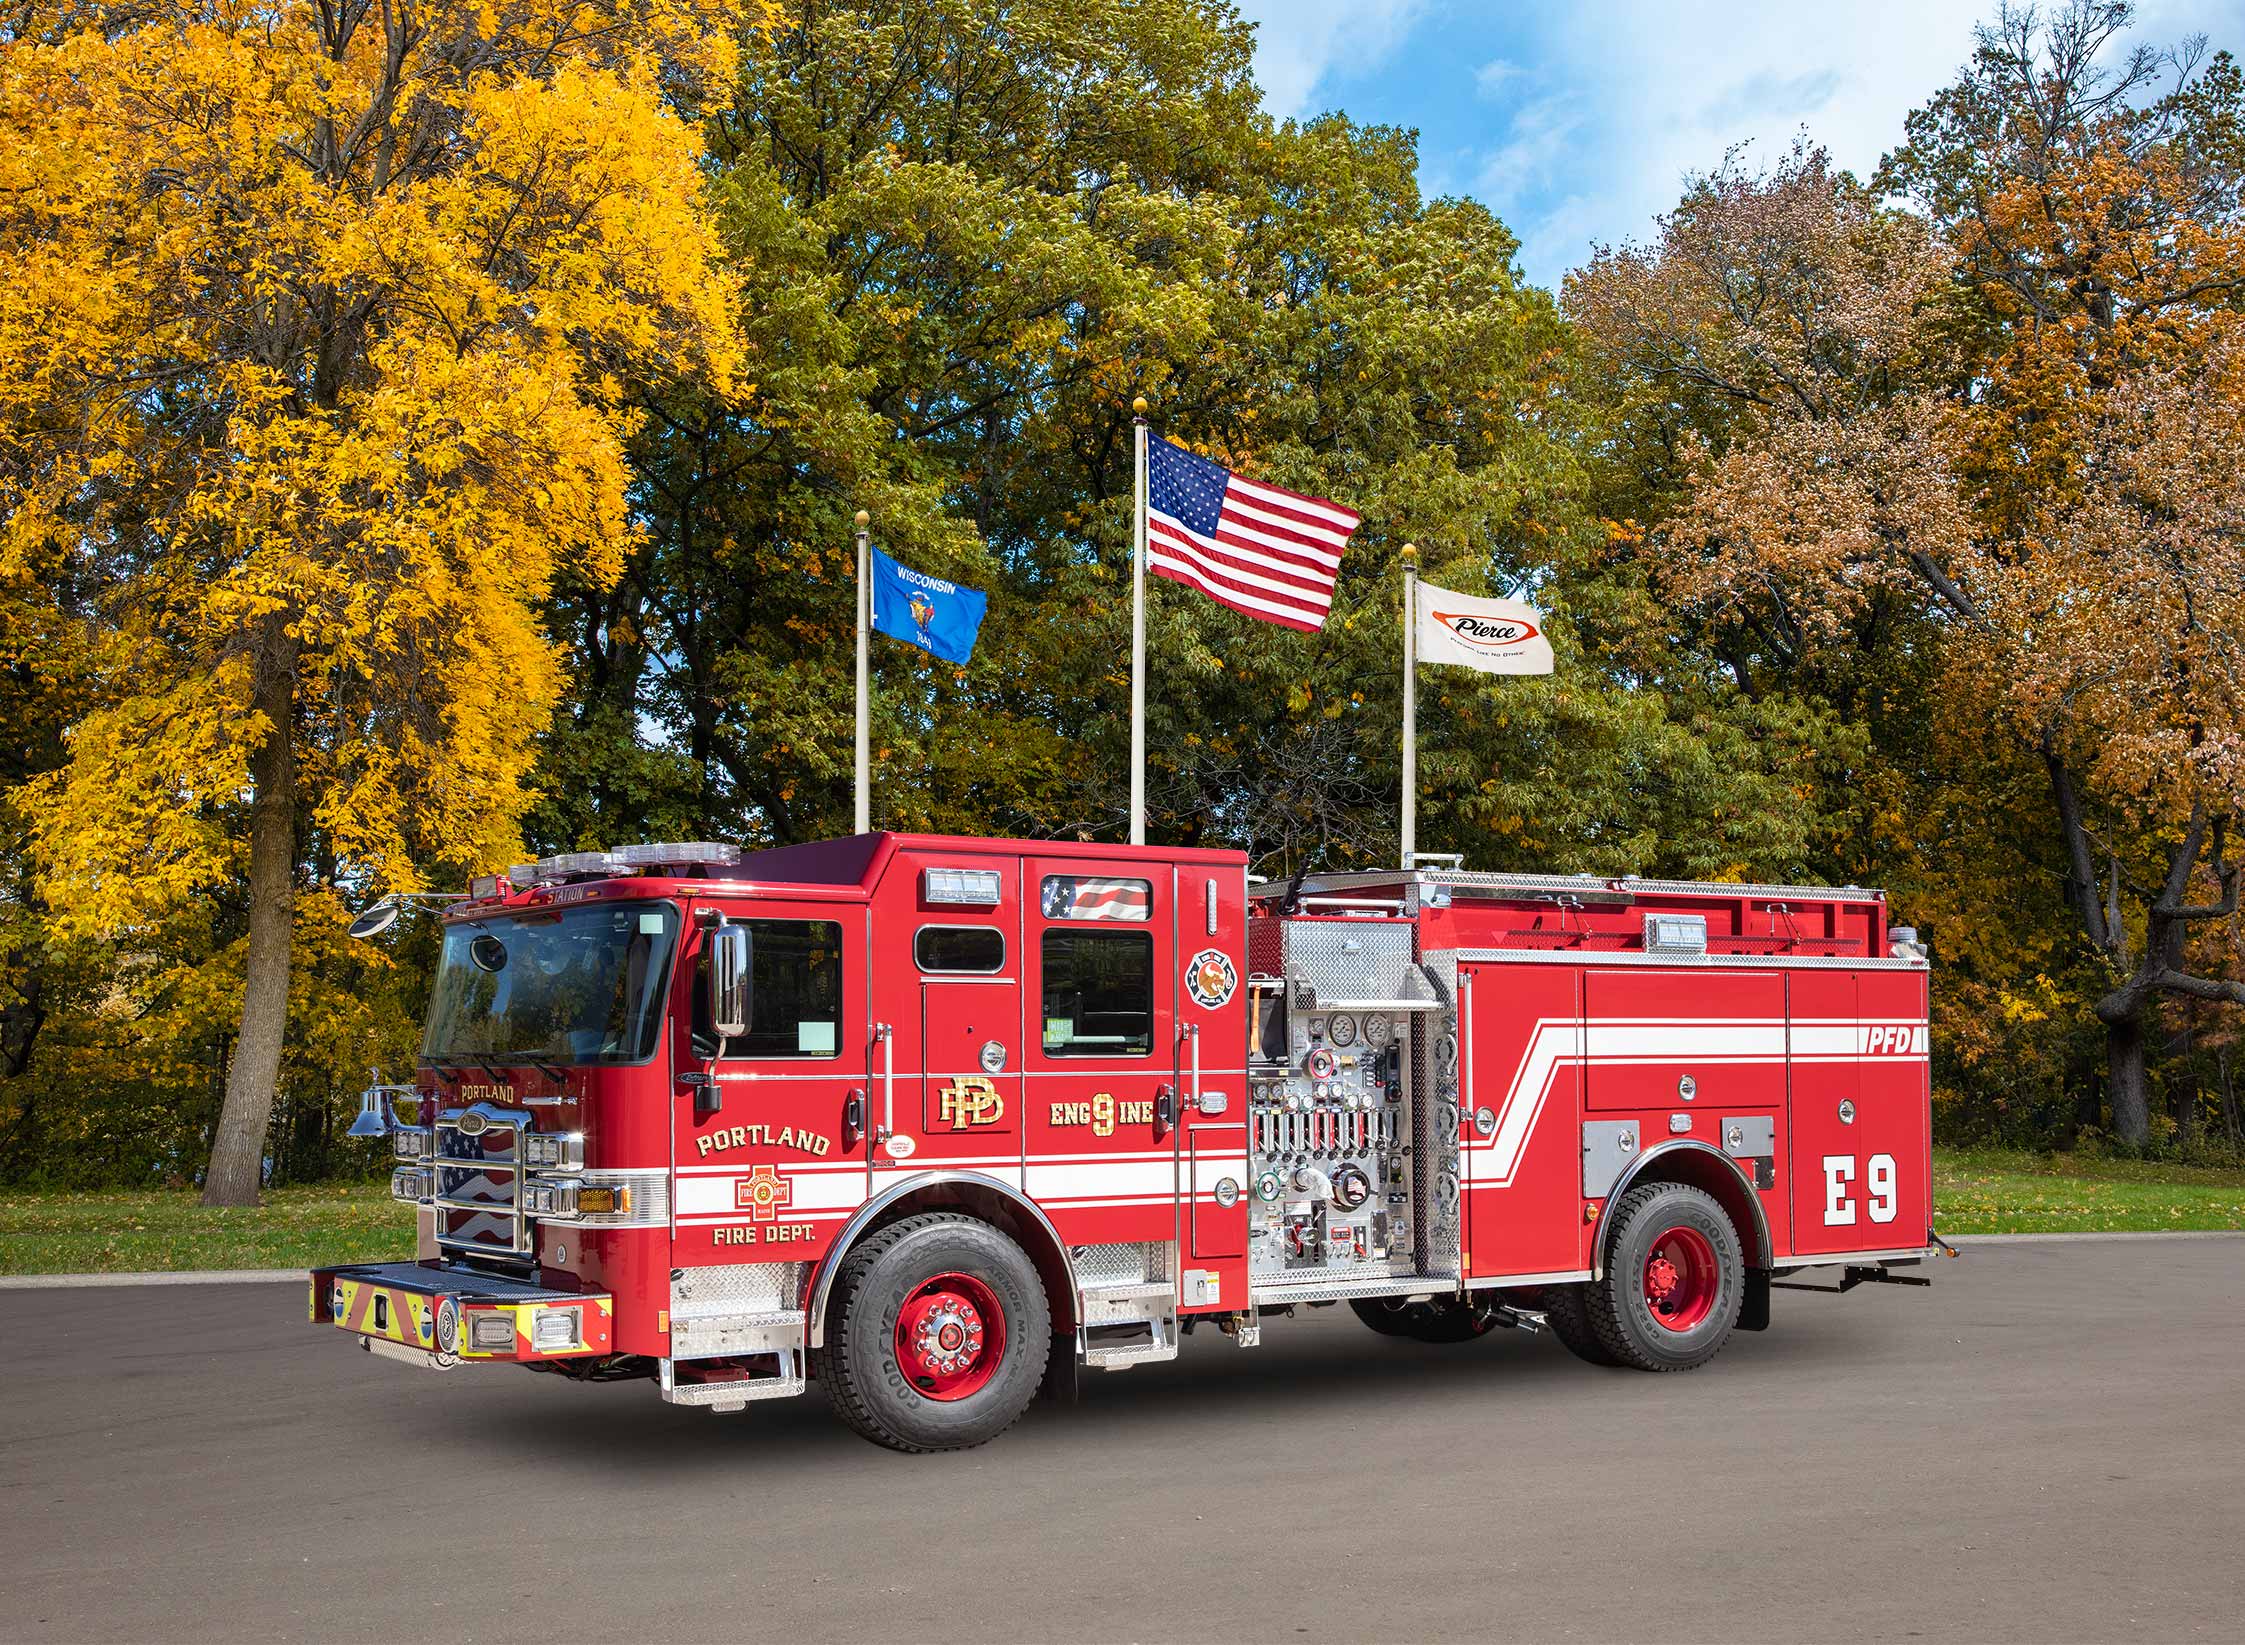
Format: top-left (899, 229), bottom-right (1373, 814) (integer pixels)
top-left (1239, 0), bottom-right (2245, 285)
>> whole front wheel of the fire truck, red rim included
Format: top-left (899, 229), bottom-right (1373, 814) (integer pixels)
top-left (819, 1212), bottom-right (1053, 1452)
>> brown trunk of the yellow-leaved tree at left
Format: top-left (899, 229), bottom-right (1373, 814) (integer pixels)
top-left (202, 637), bottom-right (296, 1205)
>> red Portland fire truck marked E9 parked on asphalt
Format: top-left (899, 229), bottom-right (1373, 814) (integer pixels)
top-left (312, 833), bottom-right (1937, 1450)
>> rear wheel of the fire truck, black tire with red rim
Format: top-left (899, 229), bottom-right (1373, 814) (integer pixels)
top-left (1585, 1183), bottom-right (1747, 1371)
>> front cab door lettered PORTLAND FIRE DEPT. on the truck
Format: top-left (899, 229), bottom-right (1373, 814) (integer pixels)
top-left (671, 902), bottom-right (871, 1268)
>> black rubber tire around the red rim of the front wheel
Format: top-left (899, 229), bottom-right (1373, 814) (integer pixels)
top-left (817, 1212), bottom-right (1053, 1452)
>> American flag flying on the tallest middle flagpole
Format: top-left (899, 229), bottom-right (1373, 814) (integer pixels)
top-left (1145, 438), bottom-right (1358, 633)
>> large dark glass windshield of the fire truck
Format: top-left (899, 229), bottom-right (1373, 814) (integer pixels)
top-left (422, 902), bottom-right (678, 1064)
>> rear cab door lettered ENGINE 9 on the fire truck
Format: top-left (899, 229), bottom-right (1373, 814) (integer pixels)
top-left (1021, 857), bottom-right (1179, 1248)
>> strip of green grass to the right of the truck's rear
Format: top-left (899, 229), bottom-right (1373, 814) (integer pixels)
top-left (1933, 1149), bottom-right (2245, 1234)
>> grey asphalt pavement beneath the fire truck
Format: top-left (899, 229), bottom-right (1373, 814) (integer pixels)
top-left (0, 1239), bottom-right (2245, 1645)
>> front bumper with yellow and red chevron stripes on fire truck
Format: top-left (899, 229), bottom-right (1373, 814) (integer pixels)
top-left (312, 1261), bottom-right (615, 1371)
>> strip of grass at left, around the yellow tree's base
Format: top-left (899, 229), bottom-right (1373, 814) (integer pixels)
top-left (0, 1183), bottom-right (413, 1275)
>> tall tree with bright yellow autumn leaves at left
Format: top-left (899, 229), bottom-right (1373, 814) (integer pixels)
top-left (0, 0), bottom-right (739, 1205)
